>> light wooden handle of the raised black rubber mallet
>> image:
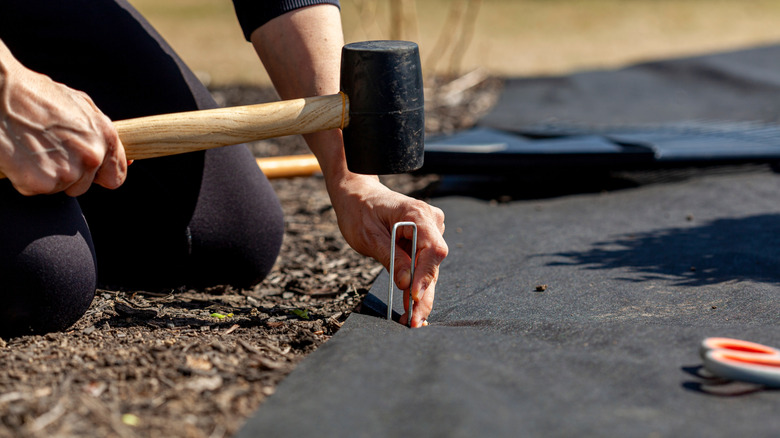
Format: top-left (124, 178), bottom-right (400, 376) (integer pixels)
top-left (0, 93), bottom-right (349, 178)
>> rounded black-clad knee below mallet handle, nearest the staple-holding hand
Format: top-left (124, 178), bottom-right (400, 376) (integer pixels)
top-left (183, 146), bottom-right (284, 288)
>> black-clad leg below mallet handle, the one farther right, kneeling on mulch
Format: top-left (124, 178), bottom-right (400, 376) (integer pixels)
top-left (79, 146), bottom-right (284, 289)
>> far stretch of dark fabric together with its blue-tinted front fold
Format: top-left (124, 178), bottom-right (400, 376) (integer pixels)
top-left (422, 46), bottom-right (780, 175)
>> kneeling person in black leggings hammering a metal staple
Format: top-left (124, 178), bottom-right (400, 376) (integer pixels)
top-left (0, 0), bottom-right (448, 337)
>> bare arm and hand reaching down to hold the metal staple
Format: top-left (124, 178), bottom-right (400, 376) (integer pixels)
top-left (252, 5), bottom-right (448, 327)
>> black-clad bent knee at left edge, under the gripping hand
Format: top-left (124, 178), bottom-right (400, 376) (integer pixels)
top-left (0, 181), bottom-right (96, 337)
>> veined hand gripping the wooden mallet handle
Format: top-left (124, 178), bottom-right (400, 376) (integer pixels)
top-left (0, 41), bottom-right (127, 196)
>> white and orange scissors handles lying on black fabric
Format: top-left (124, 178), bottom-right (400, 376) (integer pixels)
top-left (699, 338), bottom-right (780, 387)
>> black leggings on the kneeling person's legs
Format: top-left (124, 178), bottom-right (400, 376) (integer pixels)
top-left (0, 0), bottom-right (283, 336)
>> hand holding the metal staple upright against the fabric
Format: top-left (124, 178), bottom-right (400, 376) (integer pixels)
top-left (330, 174), bottom-right (448, 327)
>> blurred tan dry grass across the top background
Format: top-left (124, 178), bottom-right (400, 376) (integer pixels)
top-left (130, 0), bottom-right (780, 85)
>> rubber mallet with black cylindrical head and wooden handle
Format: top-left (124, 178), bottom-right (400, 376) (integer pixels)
top-left (0, 41), bottom-right (425, 177)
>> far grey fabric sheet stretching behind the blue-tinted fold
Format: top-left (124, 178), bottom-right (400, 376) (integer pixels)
top-left (480, 45), bottom-right (780, 135)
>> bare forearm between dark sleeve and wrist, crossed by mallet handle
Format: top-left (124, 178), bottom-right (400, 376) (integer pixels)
top-left (247, 5), bottom-right (374, 194)
